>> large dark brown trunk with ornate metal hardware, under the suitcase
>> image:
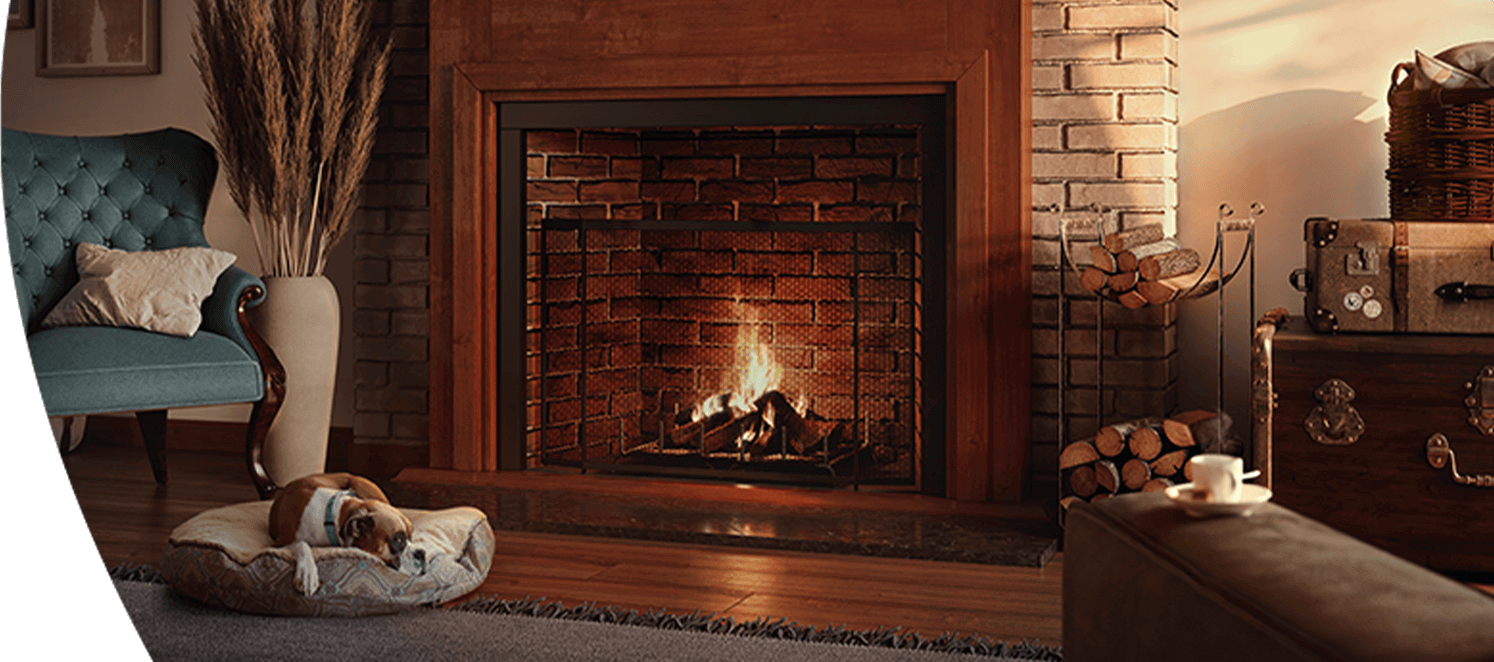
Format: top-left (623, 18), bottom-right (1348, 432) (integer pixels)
top-left (1252, 320), bottom-right (1494, 572)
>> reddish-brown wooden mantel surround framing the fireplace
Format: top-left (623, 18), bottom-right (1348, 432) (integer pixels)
top-left (430, 0), bottom-right (1032, 502)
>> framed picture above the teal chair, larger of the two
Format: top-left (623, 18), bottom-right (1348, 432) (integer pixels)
top-left (36, 0), bottom-right (161, 76)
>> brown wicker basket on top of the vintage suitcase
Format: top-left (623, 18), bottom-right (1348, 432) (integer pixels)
top-left (1385, 63), bottom-right (1494, 223)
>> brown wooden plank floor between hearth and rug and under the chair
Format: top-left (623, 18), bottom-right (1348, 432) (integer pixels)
top-left (63, 444), bottom-right (1064, 646)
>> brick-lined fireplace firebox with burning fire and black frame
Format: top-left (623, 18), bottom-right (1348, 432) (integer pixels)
top-left (498, 96), bottom-right (952, 493)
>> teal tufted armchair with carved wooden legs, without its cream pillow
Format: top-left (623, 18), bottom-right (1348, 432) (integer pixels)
top-left (0, 129), bottom-right (285, 498)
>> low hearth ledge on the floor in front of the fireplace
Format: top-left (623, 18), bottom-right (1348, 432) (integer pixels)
top-left (388, 468), bottom-right (1062, 568)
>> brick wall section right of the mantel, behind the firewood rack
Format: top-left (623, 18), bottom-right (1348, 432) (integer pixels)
top-left (1032, 0), bottom-right (1177, 496)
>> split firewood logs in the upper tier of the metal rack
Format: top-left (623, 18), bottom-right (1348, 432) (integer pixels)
top-left (1079, 224), bottom-right (1219, 308)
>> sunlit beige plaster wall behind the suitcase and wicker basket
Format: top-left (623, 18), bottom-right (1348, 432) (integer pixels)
top-left (1177, 0), bottom-right (1494, 436)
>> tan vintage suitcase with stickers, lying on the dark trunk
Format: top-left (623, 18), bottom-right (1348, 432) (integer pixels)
top-left (1291, 218), bottom-right (1494, 333)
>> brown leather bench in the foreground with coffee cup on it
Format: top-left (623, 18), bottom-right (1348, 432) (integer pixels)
top-left (1064, 493), bottom-right (1494, 662)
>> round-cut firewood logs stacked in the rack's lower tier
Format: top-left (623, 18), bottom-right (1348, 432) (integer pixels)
top-left (1058, 409), bottom-right (1240, 508)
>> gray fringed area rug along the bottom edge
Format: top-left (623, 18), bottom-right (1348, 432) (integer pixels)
top-left (111, 568), bottom-right (1062, 662)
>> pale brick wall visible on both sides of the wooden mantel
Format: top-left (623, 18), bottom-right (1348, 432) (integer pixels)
top-left (353, 0), bottom-right (1177, 499)
